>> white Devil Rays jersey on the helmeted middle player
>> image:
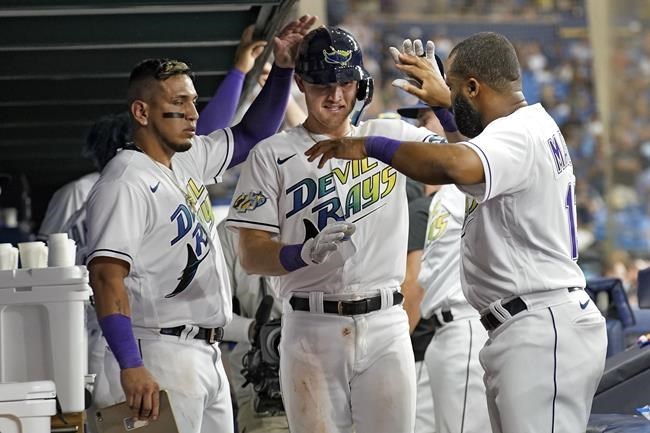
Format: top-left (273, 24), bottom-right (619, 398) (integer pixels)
top-left (227, 119), bottom-right (443, 297)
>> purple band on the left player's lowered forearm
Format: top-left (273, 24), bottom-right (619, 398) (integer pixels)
top-left (99, 314), bottom-right (144, 370)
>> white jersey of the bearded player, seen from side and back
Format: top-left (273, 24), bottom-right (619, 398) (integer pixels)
top-left (460, 104), bottom-right (585, 311)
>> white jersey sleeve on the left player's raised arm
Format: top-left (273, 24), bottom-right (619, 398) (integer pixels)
top-left (188, 128), bottom-right (234, 185)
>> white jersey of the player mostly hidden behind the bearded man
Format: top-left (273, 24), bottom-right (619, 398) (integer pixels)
top-left (418, 185), bottom-right (467, 318)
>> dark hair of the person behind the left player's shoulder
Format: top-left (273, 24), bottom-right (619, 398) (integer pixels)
top-left (81, 111), bottom-right (131, 171)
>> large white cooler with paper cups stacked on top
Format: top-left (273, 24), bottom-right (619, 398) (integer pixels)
top-left (0, 266), bottom-right (90, 412)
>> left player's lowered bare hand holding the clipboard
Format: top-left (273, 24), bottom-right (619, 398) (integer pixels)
top-left (120, 367), bottom-right (160, 421)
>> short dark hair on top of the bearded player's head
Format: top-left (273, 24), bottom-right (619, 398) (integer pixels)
top-left (449, 32), bottom-right (521, 91)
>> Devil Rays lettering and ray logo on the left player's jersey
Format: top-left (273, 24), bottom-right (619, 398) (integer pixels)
top-left (165, 178), bottom-right (214, 298)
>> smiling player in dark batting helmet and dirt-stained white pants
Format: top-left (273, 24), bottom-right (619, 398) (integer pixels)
top-left (227, 27), bottom-right (442, 433)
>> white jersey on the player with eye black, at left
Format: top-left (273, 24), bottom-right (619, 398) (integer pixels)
top-left (87, 129), bottom-right (233, 328)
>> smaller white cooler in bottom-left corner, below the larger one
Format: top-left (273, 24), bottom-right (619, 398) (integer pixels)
top-left (0, 380), bottom-right (56, 433)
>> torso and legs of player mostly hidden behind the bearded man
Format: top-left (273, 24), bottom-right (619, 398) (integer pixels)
top-left (418, 185), bottom-right (489, 433)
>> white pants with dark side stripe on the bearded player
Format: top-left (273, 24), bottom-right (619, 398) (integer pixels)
top-left (480, 289), bottom-right (607, 433)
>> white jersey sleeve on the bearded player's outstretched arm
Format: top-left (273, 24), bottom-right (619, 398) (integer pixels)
top-left (458, 115), bottom-right (534, 203)
